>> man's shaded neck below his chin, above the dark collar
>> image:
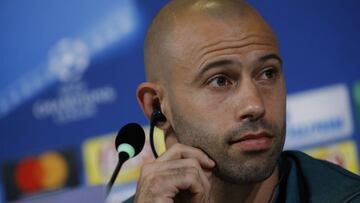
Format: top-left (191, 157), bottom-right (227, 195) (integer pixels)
top-left (211, 168), bottom-right (278, 203)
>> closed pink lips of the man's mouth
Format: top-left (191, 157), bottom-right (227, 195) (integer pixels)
top-left (229, 132), bottom-right (273, 152)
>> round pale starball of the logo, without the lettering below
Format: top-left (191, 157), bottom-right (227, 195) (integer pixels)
top-left (48, 38), bottom-right (90, 82)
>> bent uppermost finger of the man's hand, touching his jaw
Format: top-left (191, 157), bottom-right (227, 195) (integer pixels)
top-left (155, 143), bottom-right (215, 168)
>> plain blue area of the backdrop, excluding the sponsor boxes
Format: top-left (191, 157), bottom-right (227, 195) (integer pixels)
top-left (0, 0), bottom-right (360, 201)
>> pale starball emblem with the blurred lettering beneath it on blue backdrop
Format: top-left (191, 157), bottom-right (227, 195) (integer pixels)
top-left (32, 38), bottom-right (117, 125)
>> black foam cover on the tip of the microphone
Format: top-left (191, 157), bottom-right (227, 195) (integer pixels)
top-left (115, 123), bottom-right (145, 156)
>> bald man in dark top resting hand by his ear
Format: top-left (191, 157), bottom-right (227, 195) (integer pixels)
top-left (130, 0), bottom-right (360, 203)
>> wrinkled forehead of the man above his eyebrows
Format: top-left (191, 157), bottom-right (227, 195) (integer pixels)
top-left (166, 8), bottom-right (278, 65)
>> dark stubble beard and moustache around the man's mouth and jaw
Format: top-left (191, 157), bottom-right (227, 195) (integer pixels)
top-left (172, 108), bottom-right (286, 185)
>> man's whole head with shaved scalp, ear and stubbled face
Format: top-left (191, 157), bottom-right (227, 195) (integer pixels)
top-left (138, 0), bottom-right (286, 189)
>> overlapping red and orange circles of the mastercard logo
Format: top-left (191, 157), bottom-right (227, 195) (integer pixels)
top-left (14, 152), bottom-right (69, 193)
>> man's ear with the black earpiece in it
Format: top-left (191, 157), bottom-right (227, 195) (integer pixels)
top-left (136, 82), bottom-right (159, 119)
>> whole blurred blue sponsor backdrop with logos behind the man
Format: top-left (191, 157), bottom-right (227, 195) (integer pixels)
top-left (0, 0), bottom-right (360, 202)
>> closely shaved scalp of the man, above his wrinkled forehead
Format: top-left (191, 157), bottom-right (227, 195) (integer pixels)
top-left (144, 0), bottom-right (275, 84)
